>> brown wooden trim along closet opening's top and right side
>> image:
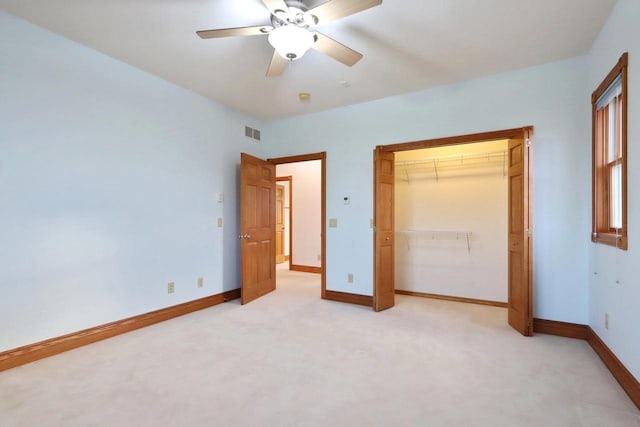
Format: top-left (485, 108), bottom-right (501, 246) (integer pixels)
top-left (374, 126), bottom-right (533, 335)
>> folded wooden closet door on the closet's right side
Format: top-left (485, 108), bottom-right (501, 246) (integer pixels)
top-left (508, 129), bottom-right (533, 336)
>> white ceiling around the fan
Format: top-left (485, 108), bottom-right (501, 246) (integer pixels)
top-left (0, 0), bottom-right (616, 120)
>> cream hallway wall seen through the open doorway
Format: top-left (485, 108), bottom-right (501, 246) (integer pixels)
top-left (276, 160), bottom-right (322, 267)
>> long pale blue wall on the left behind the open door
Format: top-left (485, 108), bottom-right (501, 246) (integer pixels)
top-left (0, 12), bottom-right (261, 351)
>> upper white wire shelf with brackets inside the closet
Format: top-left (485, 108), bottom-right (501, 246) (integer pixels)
top-left (395, 150), bottom-right (508, 182)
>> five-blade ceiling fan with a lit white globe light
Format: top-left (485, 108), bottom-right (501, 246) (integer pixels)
top-left (196, 0), bottom-right (382, 77)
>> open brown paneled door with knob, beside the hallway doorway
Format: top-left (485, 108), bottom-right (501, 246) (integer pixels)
top-left (240, 153), bottom-right (276, 304)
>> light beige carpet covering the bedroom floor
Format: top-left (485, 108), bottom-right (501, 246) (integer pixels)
top-left (0, 270), bottom-right (640, 427)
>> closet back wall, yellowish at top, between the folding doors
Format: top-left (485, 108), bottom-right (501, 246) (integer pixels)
top-left (395, 140), bottom-right (508, 302)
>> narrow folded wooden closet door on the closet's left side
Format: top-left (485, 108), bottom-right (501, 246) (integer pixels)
top-left (373, 148), bottom-right (395, 311)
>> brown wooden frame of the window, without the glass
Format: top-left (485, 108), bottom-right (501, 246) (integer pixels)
top-left (591, 52), bottom-right (629, 250)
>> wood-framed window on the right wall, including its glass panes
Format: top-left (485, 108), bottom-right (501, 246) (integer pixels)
top-left (591, 53), bottom-right (628, 250)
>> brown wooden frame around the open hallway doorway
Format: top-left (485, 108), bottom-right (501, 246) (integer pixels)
top-left (267, 151), bottom-right (327, 299)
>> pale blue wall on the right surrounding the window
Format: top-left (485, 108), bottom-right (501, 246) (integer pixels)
top-left (582, 0), bottom-right (640, 380)
